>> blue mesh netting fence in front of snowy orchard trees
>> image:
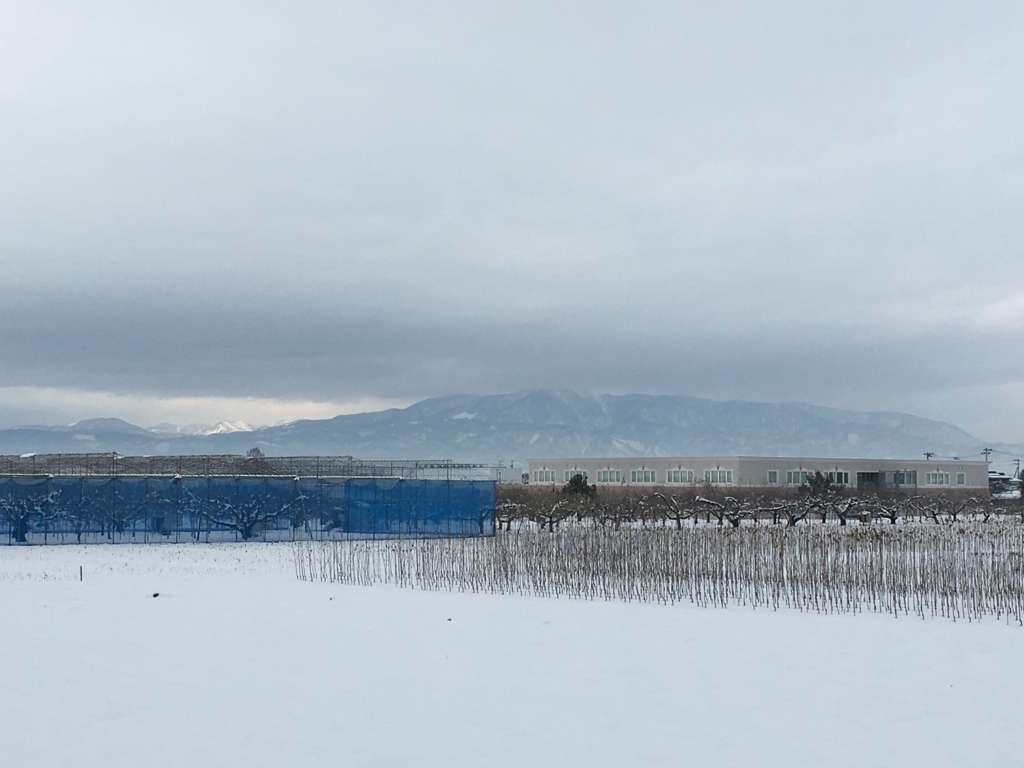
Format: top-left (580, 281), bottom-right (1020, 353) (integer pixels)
top-left (0, 476), bottom-right (496, 544)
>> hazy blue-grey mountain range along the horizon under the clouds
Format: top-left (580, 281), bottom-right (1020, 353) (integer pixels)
top-left (0, 389), bottom-right (1007, 463)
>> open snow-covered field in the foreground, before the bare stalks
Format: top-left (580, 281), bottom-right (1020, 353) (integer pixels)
top-left (0, 545), bottom-right (1024, 768)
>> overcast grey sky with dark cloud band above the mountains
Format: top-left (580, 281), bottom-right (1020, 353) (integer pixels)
top-left (0, 0), bottom-right (1024, 441)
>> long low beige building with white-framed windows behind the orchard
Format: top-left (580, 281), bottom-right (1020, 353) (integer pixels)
top-left (527, 456), bottom-right (988, 490)
